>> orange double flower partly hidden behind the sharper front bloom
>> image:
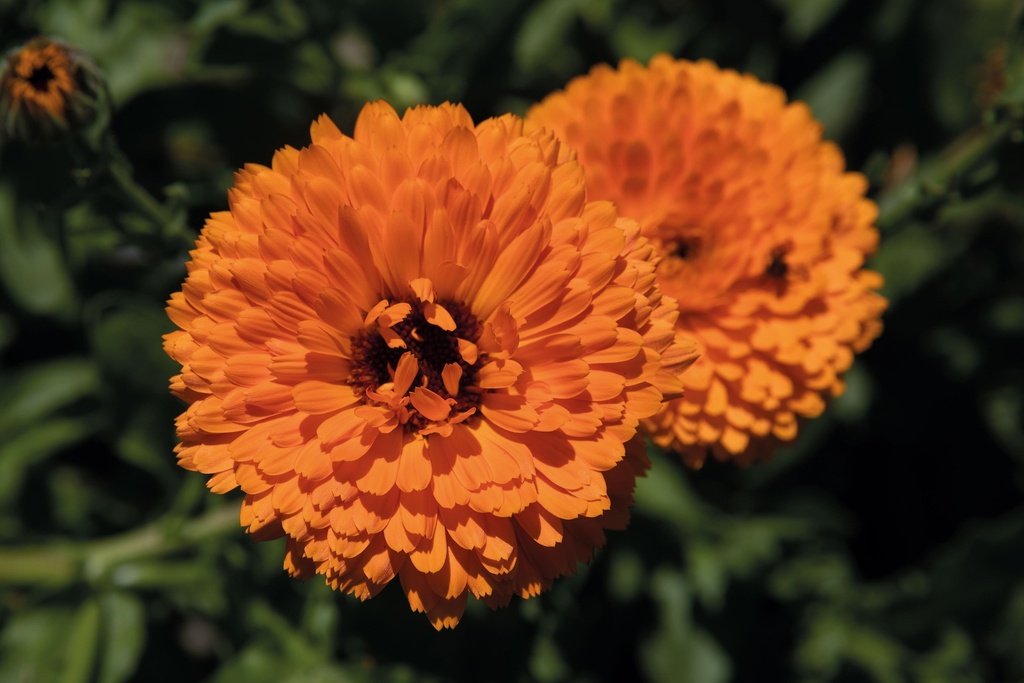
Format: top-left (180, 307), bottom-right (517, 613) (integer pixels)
top-left (527, 55), bottom-right (886, 466)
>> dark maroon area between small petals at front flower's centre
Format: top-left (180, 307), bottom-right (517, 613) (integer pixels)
top-left (349, 301), bottom-right (483, 413)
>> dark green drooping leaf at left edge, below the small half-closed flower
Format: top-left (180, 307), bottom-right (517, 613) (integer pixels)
top-left (0, 184), bottom-right (75, 315)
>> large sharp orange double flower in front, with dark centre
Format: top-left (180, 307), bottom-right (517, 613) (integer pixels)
top-left (165, 102), bottom-right (692, 629)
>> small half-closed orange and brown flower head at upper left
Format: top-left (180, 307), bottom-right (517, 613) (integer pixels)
top-left (0, 37), bottom-right (105, 140)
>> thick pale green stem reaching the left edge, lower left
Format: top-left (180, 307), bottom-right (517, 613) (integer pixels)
top-left (0, 506), bottom-right (240, 586)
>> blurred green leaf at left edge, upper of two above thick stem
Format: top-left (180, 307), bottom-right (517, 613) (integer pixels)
top-left (0, 357), bottom-right (99, 436)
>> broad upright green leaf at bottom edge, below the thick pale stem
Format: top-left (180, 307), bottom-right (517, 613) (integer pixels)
top-left (97, 591), bottom-right (145, 683)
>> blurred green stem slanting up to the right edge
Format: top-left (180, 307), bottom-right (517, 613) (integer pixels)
top-left (878, 119), bottom-right (1020, 232)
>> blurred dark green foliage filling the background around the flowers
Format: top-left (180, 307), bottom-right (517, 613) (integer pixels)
top-left (0, 0), bottom-right (1024, 683)
